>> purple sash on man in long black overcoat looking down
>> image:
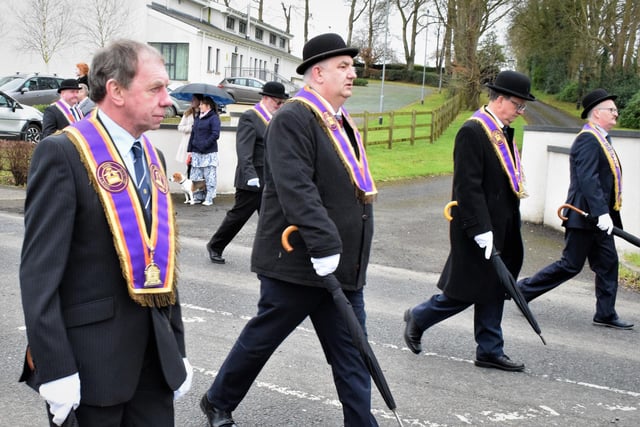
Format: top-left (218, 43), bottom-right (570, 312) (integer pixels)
top-left (469, 108), bottom-right (529, 199)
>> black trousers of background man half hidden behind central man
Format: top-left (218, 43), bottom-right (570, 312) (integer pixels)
top-left (209, 188), bottom-right (262, 255)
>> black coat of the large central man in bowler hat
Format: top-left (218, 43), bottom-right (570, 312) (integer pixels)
top-left (251, 101), bottom-right (373, 290)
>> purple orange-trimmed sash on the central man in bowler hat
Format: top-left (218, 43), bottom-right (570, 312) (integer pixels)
top-left (291, 86), bottom-right (378, 203)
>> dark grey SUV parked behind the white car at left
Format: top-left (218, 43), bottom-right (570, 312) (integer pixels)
top-left (0, 73), bottom-right (64, 105)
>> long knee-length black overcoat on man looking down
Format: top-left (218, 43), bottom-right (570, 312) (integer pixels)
top-left (438, 117), bottom-right (524, 303)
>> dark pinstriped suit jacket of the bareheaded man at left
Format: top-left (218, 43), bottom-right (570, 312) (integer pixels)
top-left (20, 134), bottom-right (186, 406)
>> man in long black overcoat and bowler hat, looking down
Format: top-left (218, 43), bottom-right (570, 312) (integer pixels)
top-left (404, 71), bottom-right (535, 371)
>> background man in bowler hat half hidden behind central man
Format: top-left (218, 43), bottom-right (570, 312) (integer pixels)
top-left (207, 82), bottom-right (289, 264)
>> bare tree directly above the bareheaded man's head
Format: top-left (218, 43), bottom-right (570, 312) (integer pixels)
top-left (79, 0), bottom-right (131, 48)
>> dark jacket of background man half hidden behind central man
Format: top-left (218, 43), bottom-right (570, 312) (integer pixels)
top-left (234, 109), bottom-right (267, 192)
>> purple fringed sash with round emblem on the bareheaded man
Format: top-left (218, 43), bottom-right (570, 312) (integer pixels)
top-left (64, 114), bottom-right (177, 307)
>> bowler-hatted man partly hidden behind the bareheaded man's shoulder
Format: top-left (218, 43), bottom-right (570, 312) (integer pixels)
top-left (42, 79), bottom-right (83, 138)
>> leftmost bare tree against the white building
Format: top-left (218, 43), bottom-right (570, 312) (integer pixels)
top-left (16, 0), bottom-right (73, 68)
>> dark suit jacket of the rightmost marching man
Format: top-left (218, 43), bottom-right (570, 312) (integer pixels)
top-left (563, 133), bottom-right (622, 230)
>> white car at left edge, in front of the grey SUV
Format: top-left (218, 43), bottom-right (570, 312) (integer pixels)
top-left (0, 91), bottom-right (42, 144)
